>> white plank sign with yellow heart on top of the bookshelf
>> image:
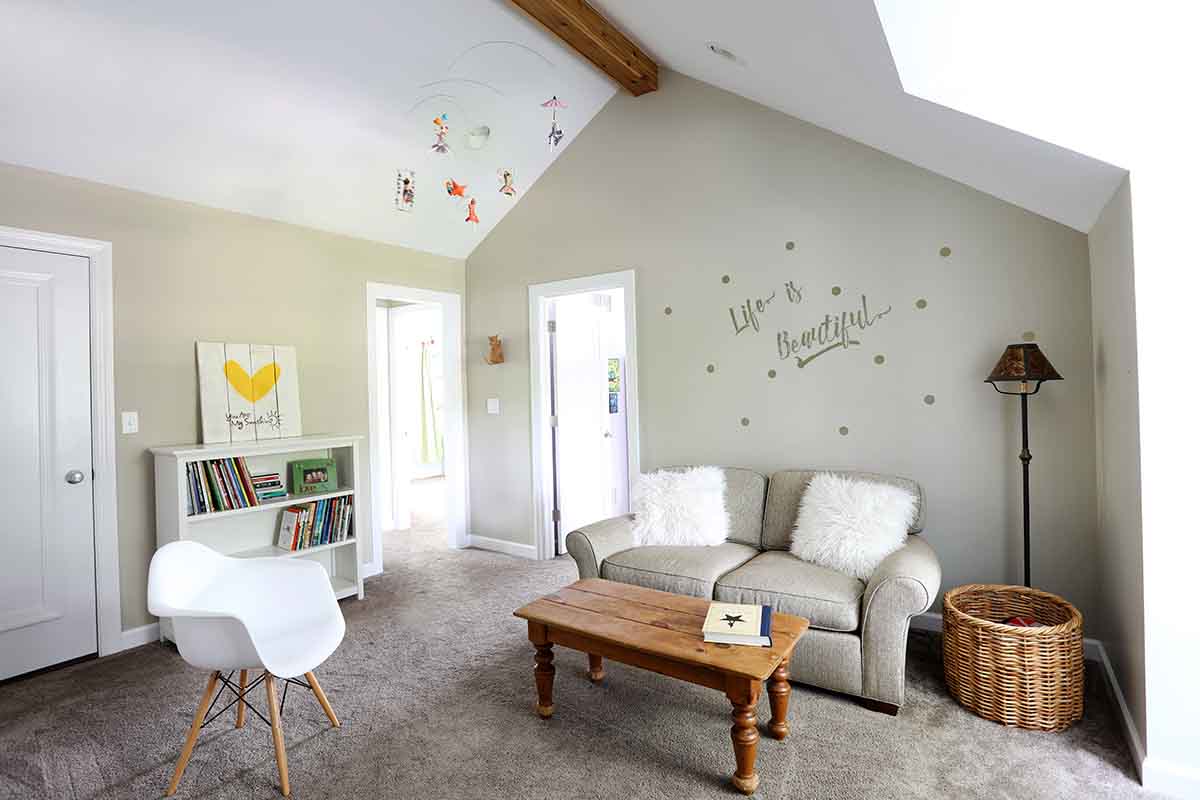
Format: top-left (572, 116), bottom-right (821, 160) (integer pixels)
top-left (196, 342), bottom-right (301, 444)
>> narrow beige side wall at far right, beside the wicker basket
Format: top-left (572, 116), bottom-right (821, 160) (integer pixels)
top-left (1087, 178), bottom-right (1146, 752)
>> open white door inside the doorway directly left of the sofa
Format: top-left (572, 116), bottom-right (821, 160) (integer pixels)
top-left (553, 294), bottom-right (612, 547)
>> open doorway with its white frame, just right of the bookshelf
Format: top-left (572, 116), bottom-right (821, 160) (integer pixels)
top-left (367, 284), bottom-right (467, 572)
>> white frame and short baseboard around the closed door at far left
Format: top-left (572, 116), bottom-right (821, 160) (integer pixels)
top-left (0, 227), bottom-right (120, 656)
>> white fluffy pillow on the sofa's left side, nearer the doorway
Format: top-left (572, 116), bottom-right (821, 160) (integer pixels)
top-left (630, 467), bottom-right (730, 546)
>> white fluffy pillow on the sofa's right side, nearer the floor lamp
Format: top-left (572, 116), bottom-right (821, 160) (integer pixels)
top-left (792, 473), bottom-right (917, 581)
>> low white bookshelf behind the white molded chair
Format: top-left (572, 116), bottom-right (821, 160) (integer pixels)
top-left (150, 435), bottom-right (365, 638)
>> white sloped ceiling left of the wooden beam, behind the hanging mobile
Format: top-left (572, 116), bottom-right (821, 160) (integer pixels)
top-left (0, 0), bottom-right (614, 258)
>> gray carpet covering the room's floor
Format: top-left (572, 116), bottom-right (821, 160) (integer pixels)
top-left (0, 547), bottom-right (1151, 800)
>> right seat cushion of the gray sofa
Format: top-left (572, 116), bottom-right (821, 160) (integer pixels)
top-left (715, 551), bottom-right (866, 631)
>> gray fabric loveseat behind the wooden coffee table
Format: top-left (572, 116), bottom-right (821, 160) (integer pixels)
top-left (566, 467), bottom-right (942, 714)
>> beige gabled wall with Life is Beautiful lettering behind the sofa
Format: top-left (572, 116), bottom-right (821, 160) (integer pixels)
top-left (467, 73), bottom-right (1096, 614)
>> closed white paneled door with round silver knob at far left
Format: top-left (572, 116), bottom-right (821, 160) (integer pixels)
top-left (0, 247), bottom-right (96, 679)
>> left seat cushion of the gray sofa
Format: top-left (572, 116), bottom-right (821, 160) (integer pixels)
top-left (600, 542), bottom-right (758, 600)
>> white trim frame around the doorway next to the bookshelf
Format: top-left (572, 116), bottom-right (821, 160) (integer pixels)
top-left (362, 282), bottom-right (469, 577)
